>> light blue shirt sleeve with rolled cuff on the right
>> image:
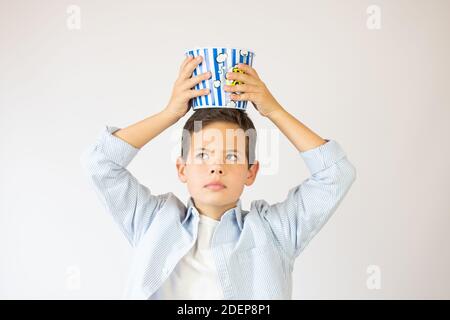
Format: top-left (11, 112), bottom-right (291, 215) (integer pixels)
top-left (260, 140), bottom-right (356, 258)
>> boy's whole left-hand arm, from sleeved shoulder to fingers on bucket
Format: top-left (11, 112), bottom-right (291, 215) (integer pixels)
top-left (81, 58), bottom-right (211, 246)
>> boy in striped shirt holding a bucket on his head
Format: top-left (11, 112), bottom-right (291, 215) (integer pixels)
top-left (82, 57), bottom-right (356, 299)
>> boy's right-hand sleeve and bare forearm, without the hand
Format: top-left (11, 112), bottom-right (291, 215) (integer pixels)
top-left (265, 108), bottom-right (356, 257)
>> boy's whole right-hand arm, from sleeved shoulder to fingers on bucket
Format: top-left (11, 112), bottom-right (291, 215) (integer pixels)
top-left (225, 64), bottom-right (356, 257)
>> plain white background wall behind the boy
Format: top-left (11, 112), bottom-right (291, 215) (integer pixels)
top-left (0, 0), bottom-right (450, 299)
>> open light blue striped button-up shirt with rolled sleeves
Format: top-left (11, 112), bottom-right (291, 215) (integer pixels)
top-left (81, 126), bottom-right (356, 299)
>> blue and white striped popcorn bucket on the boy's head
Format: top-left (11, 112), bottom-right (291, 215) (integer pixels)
top-left (185, 47), bottom-right (255, 110)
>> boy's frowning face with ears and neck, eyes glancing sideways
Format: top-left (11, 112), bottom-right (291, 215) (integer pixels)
top-left (177, 122), bottom-right (259, 217)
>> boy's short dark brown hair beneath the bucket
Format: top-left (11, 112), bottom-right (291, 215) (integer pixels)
top-left (181, 108), bottom-right (256, 169)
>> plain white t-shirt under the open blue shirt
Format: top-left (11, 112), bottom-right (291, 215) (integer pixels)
top-left (158, 214), bottom-right (224, 300)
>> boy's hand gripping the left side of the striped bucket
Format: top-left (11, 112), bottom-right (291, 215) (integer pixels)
top-left (164, 56), bottom-right (211, 119)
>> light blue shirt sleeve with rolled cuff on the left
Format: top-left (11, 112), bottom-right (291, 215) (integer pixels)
top-left (80, 126), bottom-right (170, 246)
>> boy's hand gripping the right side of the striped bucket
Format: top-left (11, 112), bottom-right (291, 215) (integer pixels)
top-left (224, 63), bottom-right (283, 117)
